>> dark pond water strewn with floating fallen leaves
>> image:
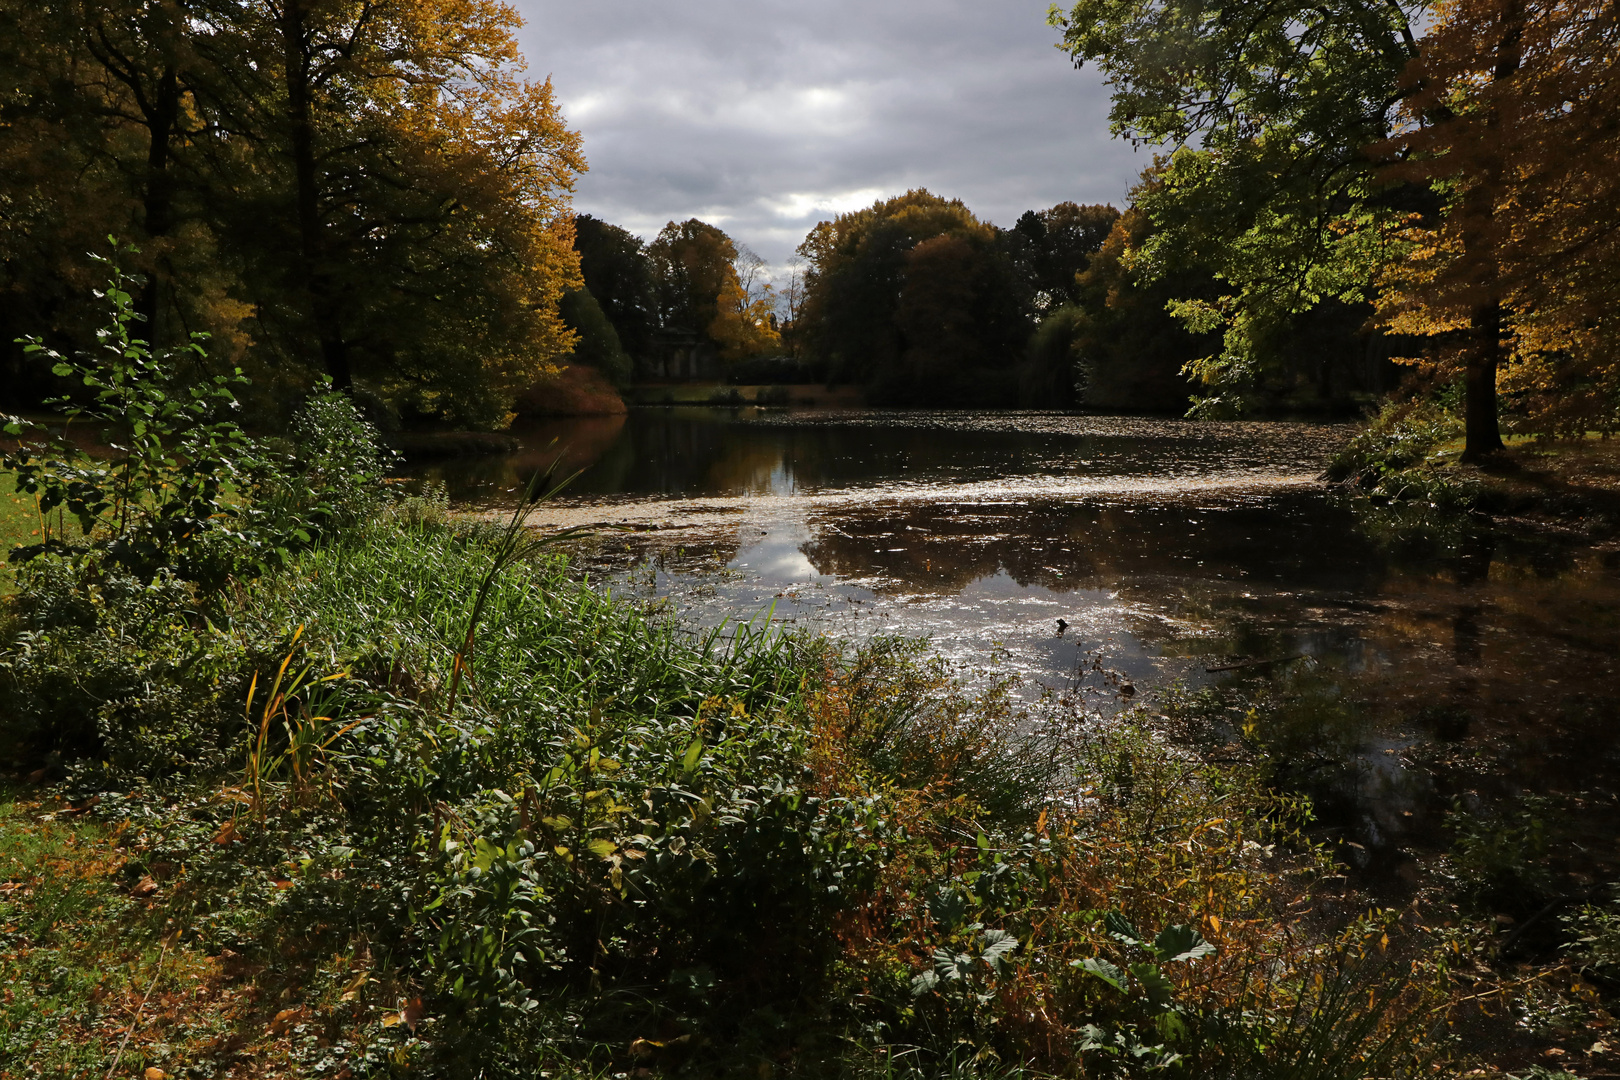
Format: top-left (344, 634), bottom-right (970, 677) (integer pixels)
top-left (416, 408), bottom-right (1620, 873)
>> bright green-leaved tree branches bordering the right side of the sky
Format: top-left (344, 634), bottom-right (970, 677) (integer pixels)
top-left (1051, 0), bottom-right (1421, 405)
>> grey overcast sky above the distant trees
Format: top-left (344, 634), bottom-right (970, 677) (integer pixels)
top-left (512, 0), bottom-right (1150, 264)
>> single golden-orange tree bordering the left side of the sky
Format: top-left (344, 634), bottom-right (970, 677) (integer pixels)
top-left (199, 0), bottom-right (585, 423)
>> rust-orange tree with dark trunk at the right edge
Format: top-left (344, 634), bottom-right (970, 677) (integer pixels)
top-left (1380, 0), bottom-right (1620, 458)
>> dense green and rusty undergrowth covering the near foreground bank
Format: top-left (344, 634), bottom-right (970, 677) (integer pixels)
top-left (0, 505), bottom-right (1458, 1077)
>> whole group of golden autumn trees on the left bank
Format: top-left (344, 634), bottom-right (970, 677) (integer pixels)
top-left (0, 0), bottom-right (585, 424)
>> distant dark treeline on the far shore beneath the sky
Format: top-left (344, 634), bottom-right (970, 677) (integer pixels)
top-left (575, 189), bottom-right (1207, 411)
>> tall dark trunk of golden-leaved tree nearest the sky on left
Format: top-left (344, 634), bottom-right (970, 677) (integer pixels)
top-left (282, 0), bottom-right (355, 393)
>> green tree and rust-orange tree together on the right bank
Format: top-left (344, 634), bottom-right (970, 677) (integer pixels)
top-left (1051, 0), bottom-right (1620, 457)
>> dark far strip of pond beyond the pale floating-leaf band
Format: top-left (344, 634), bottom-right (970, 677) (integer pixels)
top-left (415, 408), bottom-right (1343, 502)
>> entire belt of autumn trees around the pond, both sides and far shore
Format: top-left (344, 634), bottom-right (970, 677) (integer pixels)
top-left (0, 0), bottom-right (1620, 433)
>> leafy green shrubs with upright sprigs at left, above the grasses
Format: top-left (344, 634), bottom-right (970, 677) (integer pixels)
top-left (5, 259), bottom-right (390, 586)
